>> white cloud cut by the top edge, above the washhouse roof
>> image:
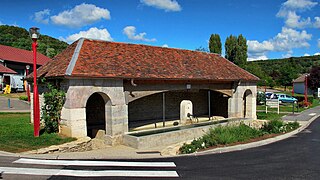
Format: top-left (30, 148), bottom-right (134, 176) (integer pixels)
top-left (140, 0), bottom-right (182, 12)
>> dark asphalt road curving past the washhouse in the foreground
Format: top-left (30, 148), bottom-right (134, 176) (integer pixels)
top-left (0, 118), bottom-right (320, 179)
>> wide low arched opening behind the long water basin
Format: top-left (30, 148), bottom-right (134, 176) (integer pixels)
top-left (128, 89), bottom-right (229, 129)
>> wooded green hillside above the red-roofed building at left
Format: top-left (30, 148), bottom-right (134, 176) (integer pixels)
top-left (0, 25), bottom-right (68, 58)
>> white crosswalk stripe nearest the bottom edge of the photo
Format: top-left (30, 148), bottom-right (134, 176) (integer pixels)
top-left (0, 167), bottom-right (179, 177)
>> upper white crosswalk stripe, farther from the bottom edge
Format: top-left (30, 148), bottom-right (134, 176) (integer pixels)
top-left (13, 158), bottom-right (176, 167)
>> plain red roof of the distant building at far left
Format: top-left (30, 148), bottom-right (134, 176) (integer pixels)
top-left (0, 44), bottom-right (50, 65)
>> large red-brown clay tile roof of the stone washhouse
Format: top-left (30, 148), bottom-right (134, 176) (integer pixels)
top-left (38, 39), bottom-right (259, 81)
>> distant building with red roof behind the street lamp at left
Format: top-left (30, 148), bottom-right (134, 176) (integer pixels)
top-left (0, 45), bottom-right (50, 90)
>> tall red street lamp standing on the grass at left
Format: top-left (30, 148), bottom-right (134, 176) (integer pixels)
top-left (29, 27), bottom-right (40, 137)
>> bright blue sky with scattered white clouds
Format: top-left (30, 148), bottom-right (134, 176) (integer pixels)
top-left (0, 0), bottom-right (320, 60)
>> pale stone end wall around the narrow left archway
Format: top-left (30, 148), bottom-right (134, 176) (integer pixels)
top-left (61, 79), bottom-right (128, 144)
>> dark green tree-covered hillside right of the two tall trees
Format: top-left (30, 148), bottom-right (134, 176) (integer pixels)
top-left (245, 55), bottom-right (320, 87)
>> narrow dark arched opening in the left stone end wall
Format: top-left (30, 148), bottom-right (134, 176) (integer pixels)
top-left (86, 93), bottom-right (110, 138)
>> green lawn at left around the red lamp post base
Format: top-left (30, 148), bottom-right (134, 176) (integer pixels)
top-left (0, 113), bottom-right (75, 152)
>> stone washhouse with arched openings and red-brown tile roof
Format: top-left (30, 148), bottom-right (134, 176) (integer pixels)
top-left (29, 38), bottom-right (259, 145)
